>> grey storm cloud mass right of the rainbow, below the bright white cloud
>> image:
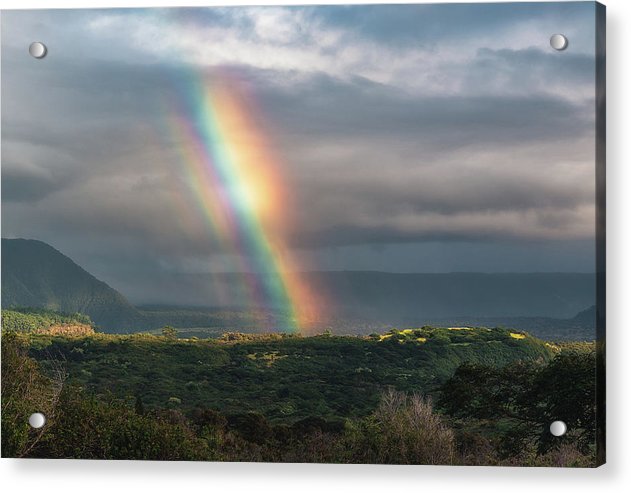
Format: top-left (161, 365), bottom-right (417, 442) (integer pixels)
top-left (244, 66), bottom-right (593, 246)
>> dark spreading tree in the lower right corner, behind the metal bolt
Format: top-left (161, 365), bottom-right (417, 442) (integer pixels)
top-left (438, 351), bottom-right (596, 458)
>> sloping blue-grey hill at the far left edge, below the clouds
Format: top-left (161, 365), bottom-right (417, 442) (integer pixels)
top-left (2, 238), bottom-right (141, 331)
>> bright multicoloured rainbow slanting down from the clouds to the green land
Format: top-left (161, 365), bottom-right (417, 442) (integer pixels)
top-left (165, 70), bottom-right (322, 332)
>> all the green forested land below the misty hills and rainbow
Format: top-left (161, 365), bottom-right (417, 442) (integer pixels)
top-left (2, 311), bottom-right (600, 467)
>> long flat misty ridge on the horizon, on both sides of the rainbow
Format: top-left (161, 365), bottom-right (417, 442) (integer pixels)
top-left (115, 271), bottom-right (596, 325)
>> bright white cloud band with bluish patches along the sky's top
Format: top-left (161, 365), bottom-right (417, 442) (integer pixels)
top-left (69, 4), bottom-right (594, 94)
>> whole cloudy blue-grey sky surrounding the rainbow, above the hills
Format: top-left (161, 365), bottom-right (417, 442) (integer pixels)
top-left (2, 2), bottom-right (595, 299)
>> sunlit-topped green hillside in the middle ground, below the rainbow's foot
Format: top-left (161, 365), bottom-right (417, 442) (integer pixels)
top-left (22, 328), bottom-right (553, 422)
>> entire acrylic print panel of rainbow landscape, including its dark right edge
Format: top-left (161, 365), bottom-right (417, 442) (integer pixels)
top-left (2, 2), bottom-right (605, 467)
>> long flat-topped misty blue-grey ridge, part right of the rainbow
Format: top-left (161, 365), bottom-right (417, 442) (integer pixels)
top-left (310, 271), bottom-right (596, 323)
